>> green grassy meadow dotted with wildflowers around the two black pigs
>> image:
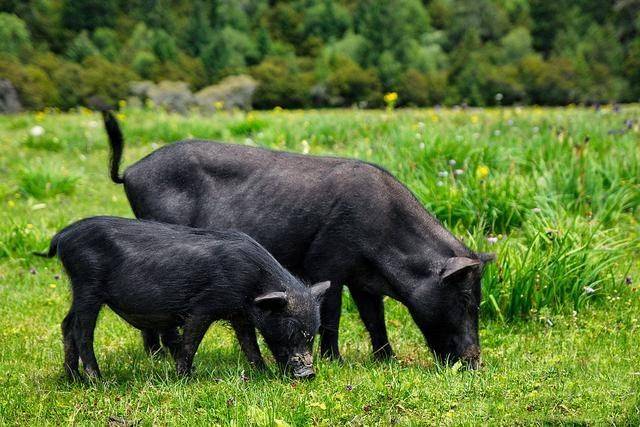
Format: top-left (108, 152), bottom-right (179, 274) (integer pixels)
top-left (0, 105), bottom-right (640, 425)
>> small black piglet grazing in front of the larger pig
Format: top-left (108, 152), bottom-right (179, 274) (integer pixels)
top-left (39, 217), bottom-right (329, 378)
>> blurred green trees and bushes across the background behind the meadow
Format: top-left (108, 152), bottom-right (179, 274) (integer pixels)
top-left (0, 0), bottom-right (640, 108)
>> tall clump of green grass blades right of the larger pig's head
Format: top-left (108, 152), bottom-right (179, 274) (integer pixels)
top-left (483, 219), bottom-right (633, 320)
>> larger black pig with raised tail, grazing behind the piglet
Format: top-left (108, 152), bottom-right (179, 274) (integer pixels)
top-left (103, 112), bottom-right (493, 367)
